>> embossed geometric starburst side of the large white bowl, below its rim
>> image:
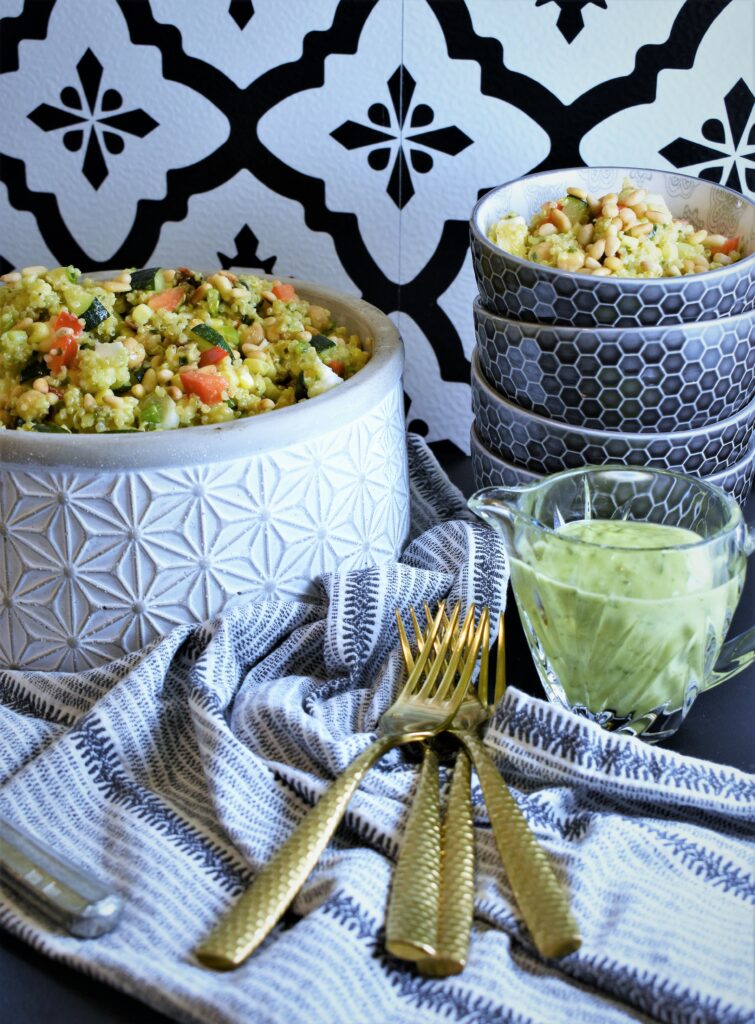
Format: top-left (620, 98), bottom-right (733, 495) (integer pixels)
top-left (0, 382), bottom-right (409, 671)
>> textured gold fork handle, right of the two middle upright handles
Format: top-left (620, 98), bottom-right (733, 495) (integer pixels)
top-left (417, 750), bottom-right (474, 978)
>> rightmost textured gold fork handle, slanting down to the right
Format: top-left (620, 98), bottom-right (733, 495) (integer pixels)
top-left (455, 730), bottom-right (582, 956)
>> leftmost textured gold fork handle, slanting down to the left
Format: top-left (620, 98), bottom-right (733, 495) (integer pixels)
top-left (197, 733), bottom-right (405, 971)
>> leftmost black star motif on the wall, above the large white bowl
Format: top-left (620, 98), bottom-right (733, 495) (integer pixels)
top-left (29, 49), bottom-right (158, 190)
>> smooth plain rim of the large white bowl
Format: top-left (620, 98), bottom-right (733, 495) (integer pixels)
top-left (0, 267), bottom-right (404, 470)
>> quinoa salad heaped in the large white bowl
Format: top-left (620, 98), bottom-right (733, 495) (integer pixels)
top-left (0, 266), bottom-right (370, 433)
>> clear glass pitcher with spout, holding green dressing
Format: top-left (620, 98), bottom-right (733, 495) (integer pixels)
top-left (469, 466), bottom-right (755, 741)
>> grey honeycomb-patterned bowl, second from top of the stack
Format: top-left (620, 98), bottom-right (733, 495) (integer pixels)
top-left (474, 300), bottom-right (755, 433)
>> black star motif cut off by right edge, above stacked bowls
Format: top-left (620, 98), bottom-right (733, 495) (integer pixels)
top-left (659, 79), bottom-right (755, 191)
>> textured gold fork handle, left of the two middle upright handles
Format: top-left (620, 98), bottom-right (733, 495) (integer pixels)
top-left (385, 743), bottom-right (441, 961)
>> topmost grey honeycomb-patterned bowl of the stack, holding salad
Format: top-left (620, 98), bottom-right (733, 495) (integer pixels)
top-left (470, 167), bottom-right (755, 328)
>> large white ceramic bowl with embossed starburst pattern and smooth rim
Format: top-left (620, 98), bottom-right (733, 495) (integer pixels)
top-left (0, 275), bottom-right (409, 671)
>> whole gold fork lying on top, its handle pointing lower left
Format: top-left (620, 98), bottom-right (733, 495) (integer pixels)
top-left (197, 606), bottom-right (481, 970)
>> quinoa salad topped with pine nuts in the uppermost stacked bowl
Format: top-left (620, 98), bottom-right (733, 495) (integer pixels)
top-left (488, 180), bottom-right (743, 278)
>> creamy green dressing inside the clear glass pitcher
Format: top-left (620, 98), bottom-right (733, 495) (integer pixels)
top-left (511, 519), bottom-right (744, 717)
